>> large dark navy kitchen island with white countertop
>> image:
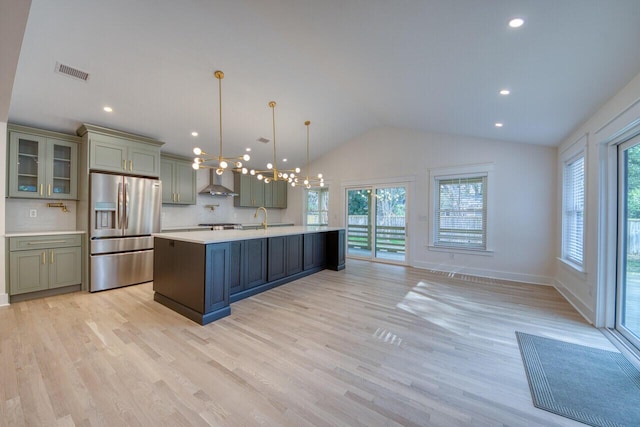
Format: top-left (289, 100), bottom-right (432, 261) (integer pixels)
top-left (153, 226), bottom-right (345, 325)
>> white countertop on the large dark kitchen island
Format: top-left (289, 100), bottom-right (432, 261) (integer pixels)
top-left (153, 225), bottom-right (344, 245)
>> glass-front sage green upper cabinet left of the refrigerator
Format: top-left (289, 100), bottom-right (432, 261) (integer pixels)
top-left (7, 125), bottom-right (81, 200)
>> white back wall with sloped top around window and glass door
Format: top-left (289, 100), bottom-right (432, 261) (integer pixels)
top-left (283, 128), bottom-right (557, 284)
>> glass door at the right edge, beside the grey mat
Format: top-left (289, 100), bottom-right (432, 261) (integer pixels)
top-left (616, 138), bottom-right (640, 348)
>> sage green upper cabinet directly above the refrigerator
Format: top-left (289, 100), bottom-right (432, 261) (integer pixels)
top-left (78, 124), bottom-right (164, 178)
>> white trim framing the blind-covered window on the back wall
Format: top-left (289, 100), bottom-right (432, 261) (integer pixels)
top-left (427, 163), bottom-right (496, 256)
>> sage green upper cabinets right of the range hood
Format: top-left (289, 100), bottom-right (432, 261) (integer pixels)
top-left (233, 172), bottom-right (287, 208)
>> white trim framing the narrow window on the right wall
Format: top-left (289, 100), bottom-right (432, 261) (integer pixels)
top-left (558, 133), bottom-right (589, 274)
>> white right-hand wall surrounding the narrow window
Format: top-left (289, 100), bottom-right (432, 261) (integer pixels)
top-left (555, 74), bottom-right (640, 327)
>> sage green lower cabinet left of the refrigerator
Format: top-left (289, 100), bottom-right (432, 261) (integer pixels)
top-left (9, 234), bottom-right (82, 295)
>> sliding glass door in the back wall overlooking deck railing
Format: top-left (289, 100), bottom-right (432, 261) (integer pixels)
top-left (346, 185), bottom-right (407, 264)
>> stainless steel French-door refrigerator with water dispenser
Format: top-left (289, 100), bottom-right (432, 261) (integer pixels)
top-left (89, 172), bottom-right (162, 292)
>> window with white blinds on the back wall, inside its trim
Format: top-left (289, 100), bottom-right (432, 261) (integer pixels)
top-left (433, 174), bottom-right (488, 250)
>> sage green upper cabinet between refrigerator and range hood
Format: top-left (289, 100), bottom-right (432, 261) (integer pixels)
top-left (160, 154), bottom-right (197, 205)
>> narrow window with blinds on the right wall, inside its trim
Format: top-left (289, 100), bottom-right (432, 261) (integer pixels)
top-left (562, 152), bottom-right (584, 267)
